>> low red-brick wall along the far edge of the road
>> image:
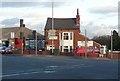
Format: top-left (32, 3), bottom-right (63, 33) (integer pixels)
top-left (13, 49), bottom-right (120, 59)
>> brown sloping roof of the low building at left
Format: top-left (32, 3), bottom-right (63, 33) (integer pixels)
top-left (0, 27), bottom-right (41, 39)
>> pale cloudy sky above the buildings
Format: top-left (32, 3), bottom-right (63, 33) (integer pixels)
top-left (0, 0), bottom-right (119, 38)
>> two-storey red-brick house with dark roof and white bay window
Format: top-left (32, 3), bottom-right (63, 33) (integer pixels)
top-left (44, 9), bottom-right (100, 52)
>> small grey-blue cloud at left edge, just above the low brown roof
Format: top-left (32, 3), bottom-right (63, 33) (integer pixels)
top-left (1, 18), bottom-right (19, 27)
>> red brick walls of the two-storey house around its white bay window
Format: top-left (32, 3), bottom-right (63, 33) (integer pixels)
top-left (45, 29), bottom-right (100, 49)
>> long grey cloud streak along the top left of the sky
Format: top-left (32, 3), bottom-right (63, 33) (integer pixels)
top-left (2, 2), bottom-right (64, 8)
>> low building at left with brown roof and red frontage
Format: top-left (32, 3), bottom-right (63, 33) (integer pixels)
top-left (0, 19), bottom-right (44, 48)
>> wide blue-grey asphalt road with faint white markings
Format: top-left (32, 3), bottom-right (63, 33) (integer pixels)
top-left (0, 55), bottom-right (118, 79)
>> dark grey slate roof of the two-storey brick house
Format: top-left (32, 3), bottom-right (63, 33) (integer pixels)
top-left (45, 18), bottom-right (79, 29)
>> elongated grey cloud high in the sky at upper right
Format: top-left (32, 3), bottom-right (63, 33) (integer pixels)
top-left (90, 6), bottom-right (118, 14)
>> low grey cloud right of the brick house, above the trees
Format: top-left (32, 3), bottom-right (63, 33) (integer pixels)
top-left (80, 22), bottom-right (118, 38)
